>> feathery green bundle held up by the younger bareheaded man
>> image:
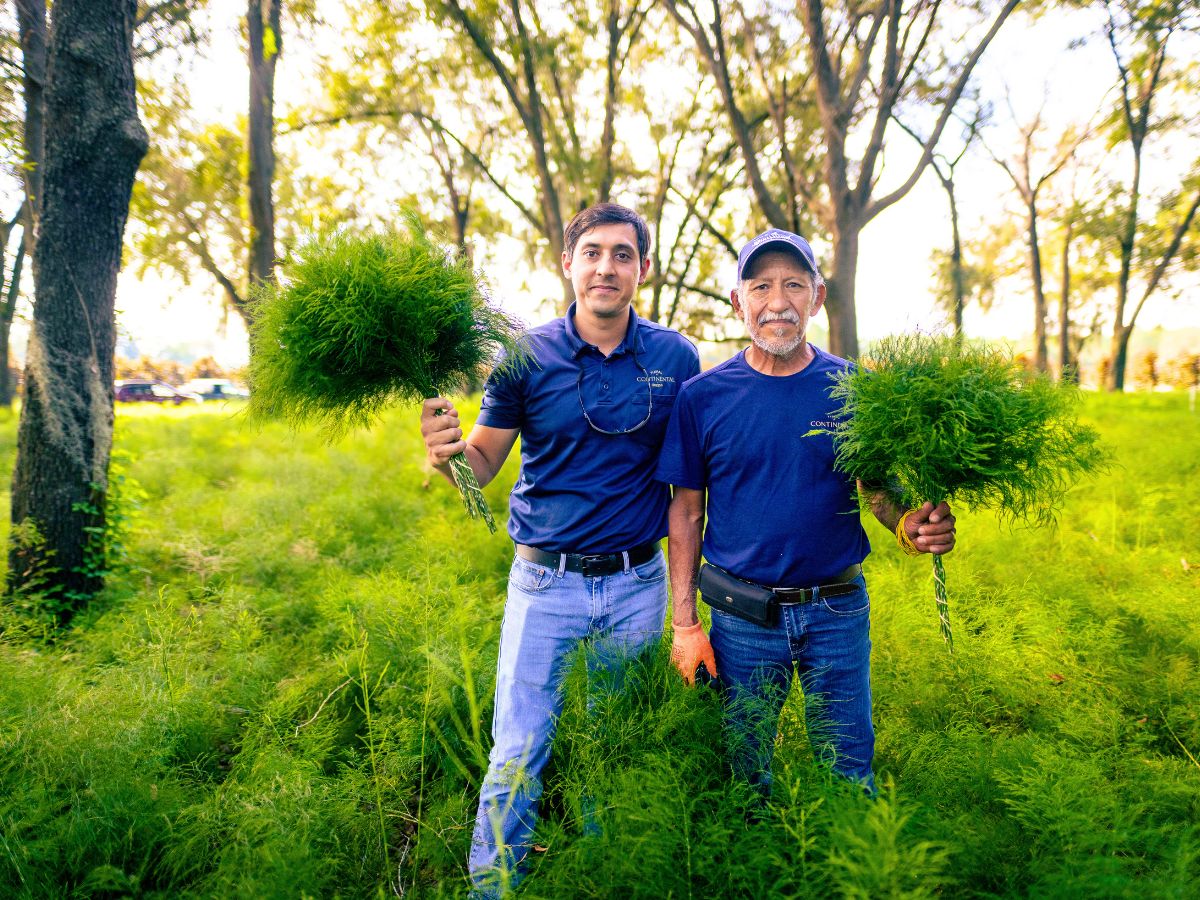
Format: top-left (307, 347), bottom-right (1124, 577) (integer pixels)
top-left (248, 211), bottom-right (527, 532)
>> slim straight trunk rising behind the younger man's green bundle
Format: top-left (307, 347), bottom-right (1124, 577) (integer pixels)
top-left (246, 0), bottom-right (282, 309)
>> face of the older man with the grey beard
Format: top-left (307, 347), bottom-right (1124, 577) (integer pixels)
top-left (730, 250), bottom-right (826, 359)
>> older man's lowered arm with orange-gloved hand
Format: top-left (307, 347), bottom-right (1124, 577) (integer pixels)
top-left (667, 487), bottom-right (716, 684)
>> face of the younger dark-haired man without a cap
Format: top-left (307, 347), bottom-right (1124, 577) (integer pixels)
top-left (563, 222), bottom-right (650, 318)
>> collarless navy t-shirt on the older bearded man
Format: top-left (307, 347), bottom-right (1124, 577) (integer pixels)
top-left (655, 347), bottom-right (871, 587)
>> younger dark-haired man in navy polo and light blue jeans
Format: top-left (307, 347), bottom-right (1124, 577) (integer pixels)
top-left (421, 203), bottom-right (700, 896)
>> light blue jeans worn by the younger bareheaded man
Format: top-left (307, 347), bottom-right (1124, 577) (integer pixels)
top-left (468, 552), bottom-right (667, 898)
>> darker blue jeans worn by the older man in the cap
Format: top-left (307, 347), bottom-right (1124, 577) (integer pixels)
top-left (709, 575), bottom-right (875, 793)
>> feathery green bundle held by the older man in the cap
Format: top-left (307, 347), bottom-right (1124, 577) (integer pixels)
top-left (829, 335), bottom-right (1106, 650)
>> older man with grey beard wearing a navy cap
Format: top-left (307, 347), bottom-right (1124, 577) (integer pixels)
top-left (656, 230), bottom-right (954, 792)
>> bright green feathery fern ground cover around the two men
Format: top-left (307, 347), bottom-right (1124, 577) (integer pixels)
top-left (0, 395), bottom-right (1200, 898)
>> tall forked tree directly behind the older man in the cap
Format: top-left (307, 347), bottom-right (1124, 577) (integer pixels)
top-left (667, 0), bottom-right (1020, 355)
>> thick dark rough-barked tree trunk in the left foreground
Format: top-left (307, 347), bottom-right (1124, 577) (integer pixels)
top-left (8, 0), bottom-right (149, 618)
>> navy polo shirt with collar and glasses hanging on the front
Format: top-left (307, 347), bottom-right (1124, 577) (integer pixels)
top-left (476, 304), bottom-right (700, 553)
